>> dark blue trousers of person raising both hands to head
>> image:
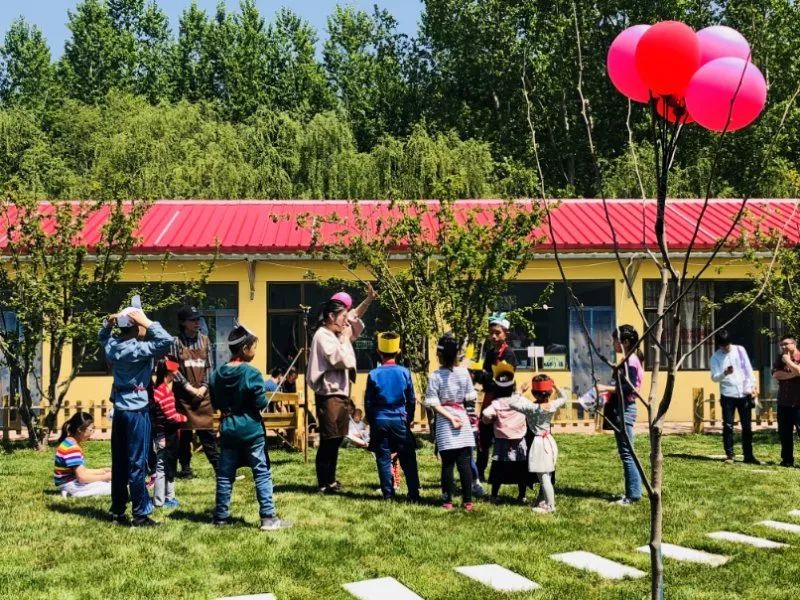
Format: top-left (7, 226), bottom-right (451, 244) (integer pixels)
top-left (111, 408), bottom-right (153, 517)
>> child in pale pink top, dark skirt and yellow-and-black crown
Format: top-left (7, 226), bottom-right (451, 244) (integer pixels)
top-left (481, 361), bottom-right (528, 502)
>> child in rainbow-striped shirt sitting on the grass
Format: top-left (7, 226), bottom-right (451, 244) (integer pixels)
top-left (53, 412), bottom-right (111, 498)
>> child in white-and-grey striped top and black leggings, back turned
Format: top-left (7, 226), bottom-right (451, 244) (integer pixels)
top-left (425, 335), bottom-right (477, 512)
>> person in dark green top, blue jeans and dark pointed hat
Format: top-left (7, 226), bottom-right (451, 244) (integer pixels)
top-left (210, 325), bottom-right (290, 531)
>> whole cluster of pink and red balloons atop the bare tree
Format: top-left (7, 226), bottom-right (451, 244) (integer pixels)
top-left (607, 21), bottom-right (767, 131)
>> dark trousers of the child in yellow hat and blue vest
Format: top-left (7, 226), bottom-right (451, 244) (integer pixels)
top-left (370, 418), bottom-right (419, 499)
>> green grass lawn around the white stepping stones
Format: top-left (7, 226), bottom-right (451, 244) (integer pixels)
top-left (0, 433), bottom-right (800, 600)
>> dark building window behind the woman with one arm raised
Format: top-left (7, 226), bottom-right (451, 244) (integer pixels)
top-left (267, 282), bottom-right (391, 371)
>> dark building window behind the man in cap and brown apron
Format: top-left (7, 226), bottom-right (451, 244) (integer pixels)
top-left (72, 283), bottom-right (239, 375)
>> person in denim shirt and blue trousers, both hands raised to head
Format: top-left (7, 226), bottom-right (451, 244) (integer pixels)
top-left (98, 302), bottom-right (172, 527)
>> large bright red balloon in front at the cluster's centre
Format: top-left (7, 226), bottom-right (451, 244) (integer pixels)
top-left (636, 21), bottom-right (700, 96)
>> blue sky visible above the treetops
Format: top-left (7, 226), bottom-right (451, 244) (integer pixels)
top-left (0, 0), bottom-right (422, 57)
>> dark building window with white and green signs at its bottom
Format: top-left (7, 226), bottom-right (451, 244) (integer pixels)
top-left (495, 281), bottom-right (614, 371)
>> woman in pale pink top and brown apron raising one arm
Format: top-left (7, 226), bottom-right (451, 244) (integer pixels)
top-left (306, 284), bottom-right (377, 494)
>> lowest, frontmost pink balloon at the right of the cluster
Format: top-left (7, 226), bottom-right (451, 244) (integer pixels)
top-left (686, 58), bottom-right (767, 131)
